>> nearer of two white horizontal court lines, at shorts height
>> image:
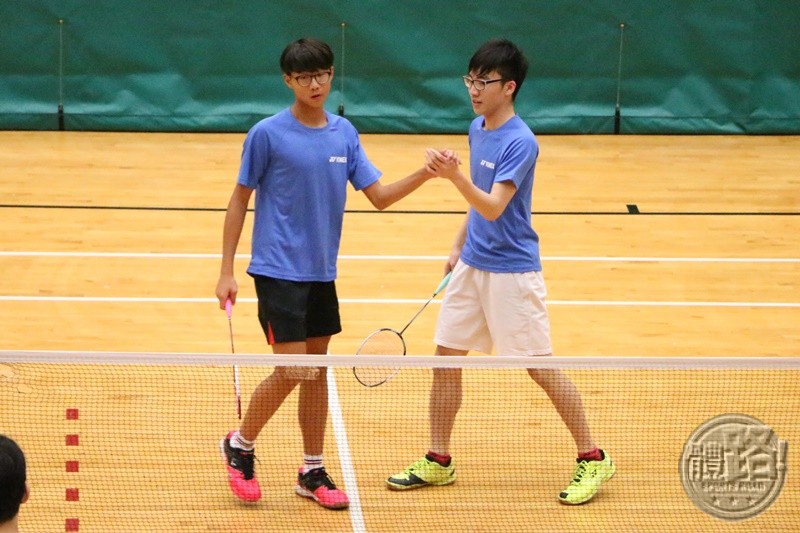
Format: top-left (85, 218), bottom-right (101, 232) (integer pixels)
top-left (0, 296), bottom-right (800, 308)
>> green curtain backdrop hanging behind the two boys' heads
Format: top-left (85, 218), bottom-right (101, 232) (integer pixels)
top-left (0, 0), bottom-right (800, 134)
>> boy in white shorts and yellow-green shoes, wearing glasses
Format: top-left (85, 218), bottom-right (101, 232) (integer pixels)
top-left (386, 40), bottom-right (616, 504)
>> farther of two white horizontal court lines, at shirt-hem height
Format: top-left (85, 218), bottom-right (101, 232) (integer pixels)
top-left (0, 250), bottom-right (800, 263)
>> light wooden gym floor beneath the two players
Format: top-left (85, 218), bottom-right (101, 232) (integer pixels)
top-left (0, 132), bottom-right (800, 531)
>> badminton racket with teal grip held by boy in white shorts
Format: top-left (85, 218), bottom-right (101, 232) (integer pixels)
top-left (353, 272), bottom-right (452, 387)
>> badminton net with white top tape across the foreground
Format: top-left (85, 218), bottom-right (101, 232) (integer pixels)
top-left (0, 351), bottom-right (800, 533)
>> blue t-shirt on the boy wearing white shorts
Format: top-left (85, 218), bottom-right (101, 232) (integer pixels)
top-left (461, 115), bottom-right (542, 272)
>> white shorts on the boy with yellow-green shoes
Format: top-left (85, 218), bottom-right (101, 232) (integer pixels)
top-left (434, 261), bottom-right (553, 355)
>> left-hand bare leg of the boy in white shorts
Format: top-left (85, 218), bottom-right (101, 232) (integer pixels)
top-left (428, 346), bottom-right (467, 454)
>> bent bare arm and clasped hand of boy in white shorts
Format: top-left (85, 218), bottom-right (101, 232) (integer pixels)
top-left (426, 148), bottom-right (517, 221)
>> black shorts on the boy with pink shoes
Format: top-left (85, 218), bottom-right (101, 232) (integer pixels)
top-left (253, 275), bottom-right (342, 344)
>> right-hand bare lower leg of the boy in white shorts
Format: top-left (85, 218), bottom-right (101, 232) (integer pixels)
top-left (528, 368), bottom-right (595, 453)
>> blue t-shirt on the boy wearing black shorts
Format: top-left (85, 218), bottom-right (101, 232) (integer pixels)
top-left (238, 109), bottom-right (381, 281)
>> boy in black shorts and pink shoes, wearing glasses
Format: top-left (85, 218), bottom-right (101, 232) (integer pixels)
top-left (216, 39), bottom-right (433, 509)
